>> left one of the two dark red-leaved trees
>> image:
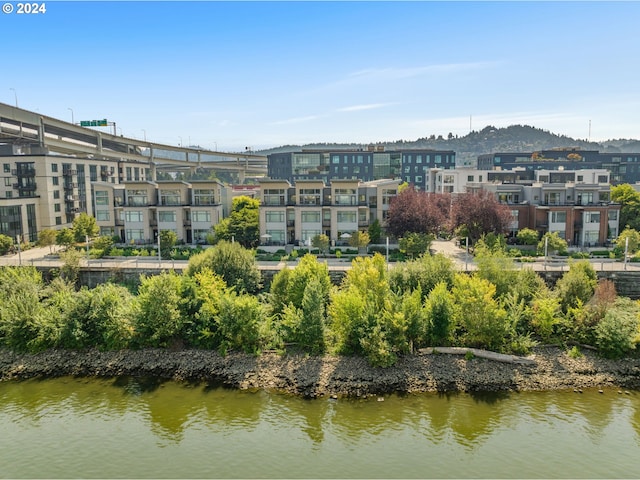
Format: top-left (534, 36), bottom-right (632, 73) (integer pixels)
top-left (387, 186), bottom-right (451, 238)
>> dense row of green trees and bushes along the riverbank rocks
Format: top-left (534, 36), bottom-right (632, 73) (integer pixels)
top-left (0, 241), bottom-right (640, 367)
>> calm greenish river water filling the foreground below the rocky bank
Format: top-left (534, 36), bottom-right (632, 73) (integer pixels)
top-left (0, 377), bottom-right (640, 478)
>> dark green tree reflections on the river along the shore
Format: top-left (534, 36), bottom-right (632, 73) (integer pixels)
top-left (0, 377), bottom-right (640, 451)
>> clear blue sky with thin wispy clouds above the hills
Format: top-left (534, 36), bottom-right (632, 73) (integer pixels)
top-left (0, 0), bottom-right (640, 151)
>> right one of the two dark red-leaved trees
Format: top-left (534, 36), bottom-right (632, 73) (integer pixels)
top-left (451, 191), bottom-right (513, 244)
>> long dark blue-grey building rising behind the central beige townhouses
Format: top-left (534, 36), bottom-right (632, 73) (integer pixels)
top-left (267, 146), bottom-right (456, 189)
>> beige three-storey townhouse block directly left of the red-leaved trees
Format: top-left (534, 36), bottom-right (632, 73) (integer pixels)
top-left (259, 179), bottom-right (400, 245)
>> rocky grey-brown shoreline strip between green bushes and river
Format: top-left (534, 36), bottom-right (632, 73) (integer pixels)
top-left (0, 347), bottom-right (640, 398)
